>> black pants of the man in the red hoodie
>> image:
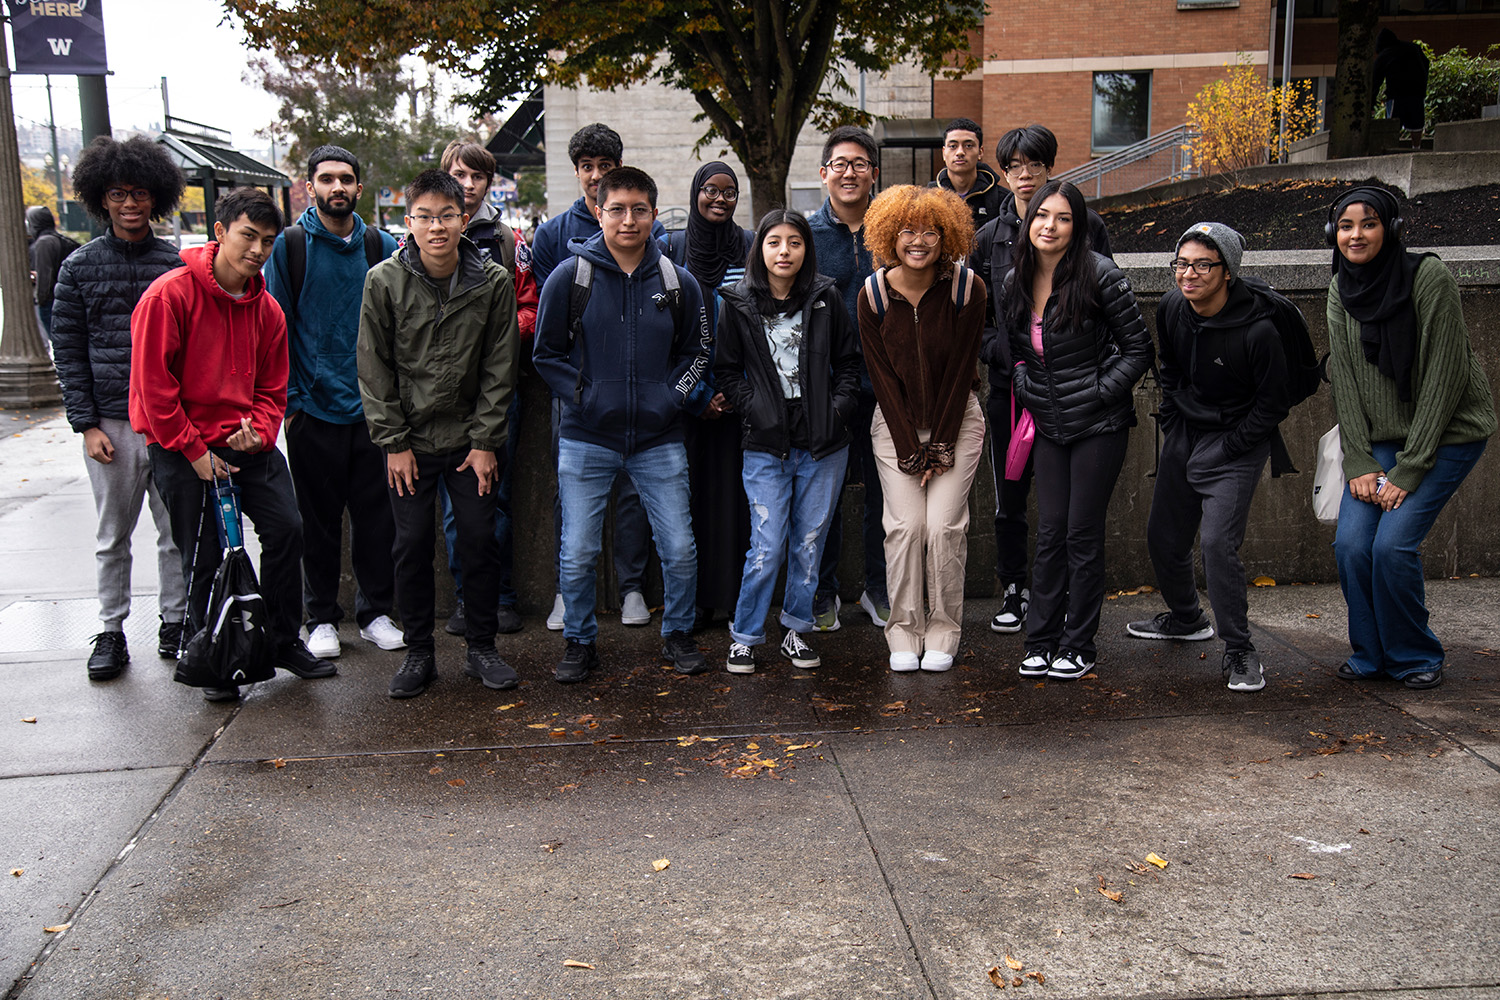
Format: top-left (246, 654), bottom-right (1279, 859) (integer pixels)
top-left (147, 444), bottom-right (302, 645)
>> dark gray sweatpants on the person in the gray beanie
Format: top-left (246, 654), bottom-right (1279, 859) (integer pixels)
top-left (1146, 427), bottom-right (1271, 649)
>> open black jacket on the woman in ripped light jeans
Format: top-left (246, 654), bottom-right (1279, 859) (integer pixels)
top-left (714, 274), bottom-right (860, 459)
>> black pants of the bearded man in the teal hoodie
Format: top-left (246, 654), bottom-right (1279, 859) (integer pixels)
top-left (285, 414), bottom-right (396, 630)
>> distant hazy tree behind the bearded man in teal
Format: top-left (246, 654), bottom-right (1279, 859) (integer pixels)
top-left (245, 55), bottom-right (464, 219)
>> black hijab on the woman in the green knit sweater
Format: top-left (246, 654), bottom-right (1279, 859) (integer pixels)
top-left (1329, 187), bottom-right (1434, 403)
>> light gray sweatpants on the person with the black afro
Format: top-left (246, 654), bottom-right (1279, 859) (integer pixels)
top-left (84, 417), bottom-right (188, 631)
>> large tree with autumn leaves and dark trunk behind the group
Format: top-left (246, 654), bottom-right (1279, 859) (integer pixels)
top-left (224, 0), bottom-right (986, 207)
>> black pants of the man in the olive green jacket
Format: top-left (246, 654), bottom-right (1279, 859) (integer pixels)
top-left (387, 448), bottom-right (506, 651)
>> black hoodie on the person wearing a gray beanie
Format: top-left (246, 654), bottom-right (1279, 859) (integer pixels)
top-left (1157, 280), bottom-right (1290, 459)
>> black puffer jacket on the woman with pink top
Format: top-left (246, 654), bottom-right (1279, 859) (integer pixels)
top-left (1001, 253), bottom-right (1155, 444)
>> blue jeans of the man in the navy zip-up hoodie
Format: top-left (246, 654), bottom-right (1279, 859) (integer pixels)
top-left (558, 438), bottom-right (698, 643)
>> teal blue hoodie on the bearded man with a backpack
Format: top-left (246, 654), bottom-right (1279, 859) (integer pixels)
top-left (263, 208), bottom-right (396, 424)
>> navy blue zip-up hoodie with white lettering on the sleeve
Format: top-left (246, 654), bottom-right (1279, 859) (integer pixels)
top-left (533, 234), bottom-right (713, 454)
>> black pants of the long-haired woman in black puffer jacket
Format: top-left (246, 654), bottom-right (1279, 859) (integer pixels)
top-left (1026, 427), bottom-right (1130, 660)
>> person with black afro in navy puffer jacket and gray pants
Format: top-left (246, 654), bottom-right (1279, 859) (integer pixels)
top-left (53, 136), bottom-right (188, 681)
